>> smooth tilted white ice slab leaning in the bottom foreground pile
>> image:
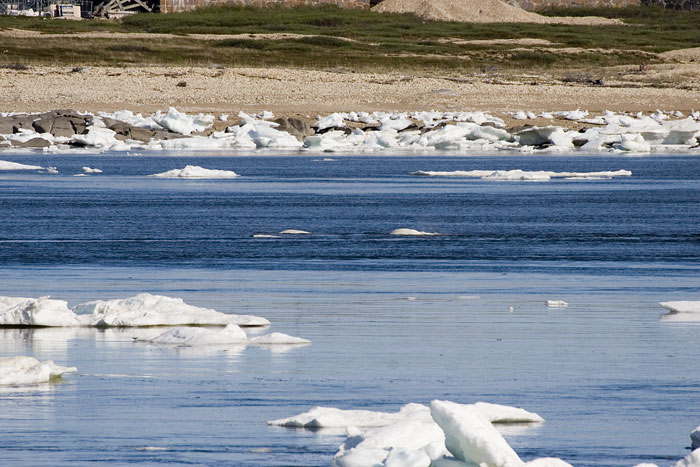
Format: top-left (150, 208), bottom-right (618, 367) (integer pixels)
top-left (430, 400), bottom-right (523, 467)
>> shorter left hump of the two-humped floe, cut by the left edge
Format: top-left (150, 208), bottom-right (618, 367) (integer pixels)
top-left (0, 297), bottom-right (80, 327)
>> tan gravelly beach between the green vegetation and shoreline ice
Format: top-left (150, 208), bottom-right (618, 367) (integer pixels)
top-left (0, 65), bottom-right (700, 124)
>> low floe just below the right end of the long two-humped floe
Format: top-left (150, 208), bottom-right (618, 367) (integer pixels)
top-left (137, 324), bottom-right (311, 346)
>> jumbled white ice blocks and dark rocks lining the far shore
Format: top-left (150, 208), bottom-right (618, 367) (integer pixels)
top-left (0, 108), bottom-right (700, 154)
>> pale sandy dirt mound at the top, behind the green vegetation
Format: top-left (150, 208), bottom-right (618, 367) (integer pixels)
top-left (373, 0), bottom-right (621, 25)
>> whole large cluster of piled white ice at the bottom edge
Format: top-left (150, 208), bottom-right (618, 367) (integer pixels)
top-left (268, 400), bottom-right (569, 467)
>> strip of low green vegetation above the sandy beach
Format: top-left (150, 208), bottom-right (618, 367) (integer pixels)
top-left (0, 6), bottom-right (700, 72)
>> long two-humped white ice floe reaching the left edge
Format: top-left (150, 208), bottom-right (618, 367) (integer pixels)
top-left (0, 293), bottom-right (270, 327)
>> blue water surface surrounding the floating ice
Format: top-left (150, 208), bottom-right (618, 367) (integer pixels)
top-left (0, 154), bottom-right (700, 466)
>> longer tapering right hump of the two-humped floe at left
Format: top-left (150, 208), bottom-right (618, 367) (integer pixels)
top-left (73, 293), bottom-right (270, 326)
